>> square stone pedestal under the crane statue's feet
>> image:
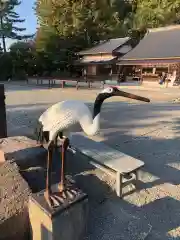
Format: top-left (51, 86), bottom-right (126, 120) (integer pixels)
top-left (29, 185), bottom-right (88, 240)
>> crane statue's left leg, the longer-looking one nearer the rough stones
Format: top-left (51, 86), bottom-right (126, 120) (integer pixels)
top-left (44, 141), bottom-right (54, 206)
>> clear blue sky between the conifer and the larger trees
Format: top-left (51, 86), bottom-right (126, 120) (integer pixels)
top-left (7, 0), bottom-right (37, 47)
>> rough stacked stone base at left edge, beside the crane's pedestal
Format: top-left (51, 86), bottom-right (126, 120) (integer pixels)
top-left (0, 136), bottom-right (47, 240)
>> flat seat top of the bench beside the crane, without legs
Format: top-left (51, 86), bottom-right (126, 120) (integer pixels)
top-left (70, 133), bottom-right (144, 174)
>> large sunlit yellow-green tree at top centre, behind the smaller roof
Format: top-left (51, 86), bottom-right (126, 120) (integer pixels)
top-left (36, 0), bottom-right (131, 47)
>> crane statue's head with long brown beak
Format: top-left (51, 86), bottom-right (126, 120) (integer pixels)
top-left (98, 86), bottom-right (150, 102)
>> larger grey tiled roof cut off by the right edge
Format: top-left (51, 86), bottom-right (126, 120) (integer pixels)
top-left (120, 25), bottom-right (180, 62)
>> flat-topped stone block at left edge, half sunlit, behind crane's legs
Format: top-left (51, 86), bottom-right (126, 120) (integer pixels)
top-left (0, 136), bottom-right (47, 169)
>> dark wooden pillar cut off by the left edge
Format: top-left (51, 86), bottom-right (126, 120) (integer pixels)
top-left (0, 84), bottom-right (7, 138)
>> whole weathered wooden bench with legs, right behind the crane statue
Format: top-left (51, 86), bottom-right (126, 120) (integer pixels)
top-left (71, 133), bottom-right (144, 198)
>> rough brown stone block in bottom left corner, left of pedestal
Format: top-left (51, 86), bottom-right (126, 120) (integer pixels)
top-left (0, 161), bottom-right (31, 240)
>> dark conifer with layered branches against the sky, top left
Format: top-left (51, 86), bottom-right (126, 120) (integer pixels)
top-left (0, 0), bottom-right (32, 52)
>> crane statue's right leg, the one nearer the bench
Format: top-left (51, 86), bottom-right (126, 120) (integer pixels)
top-left (59, 138), bottom-right (69, 192)
